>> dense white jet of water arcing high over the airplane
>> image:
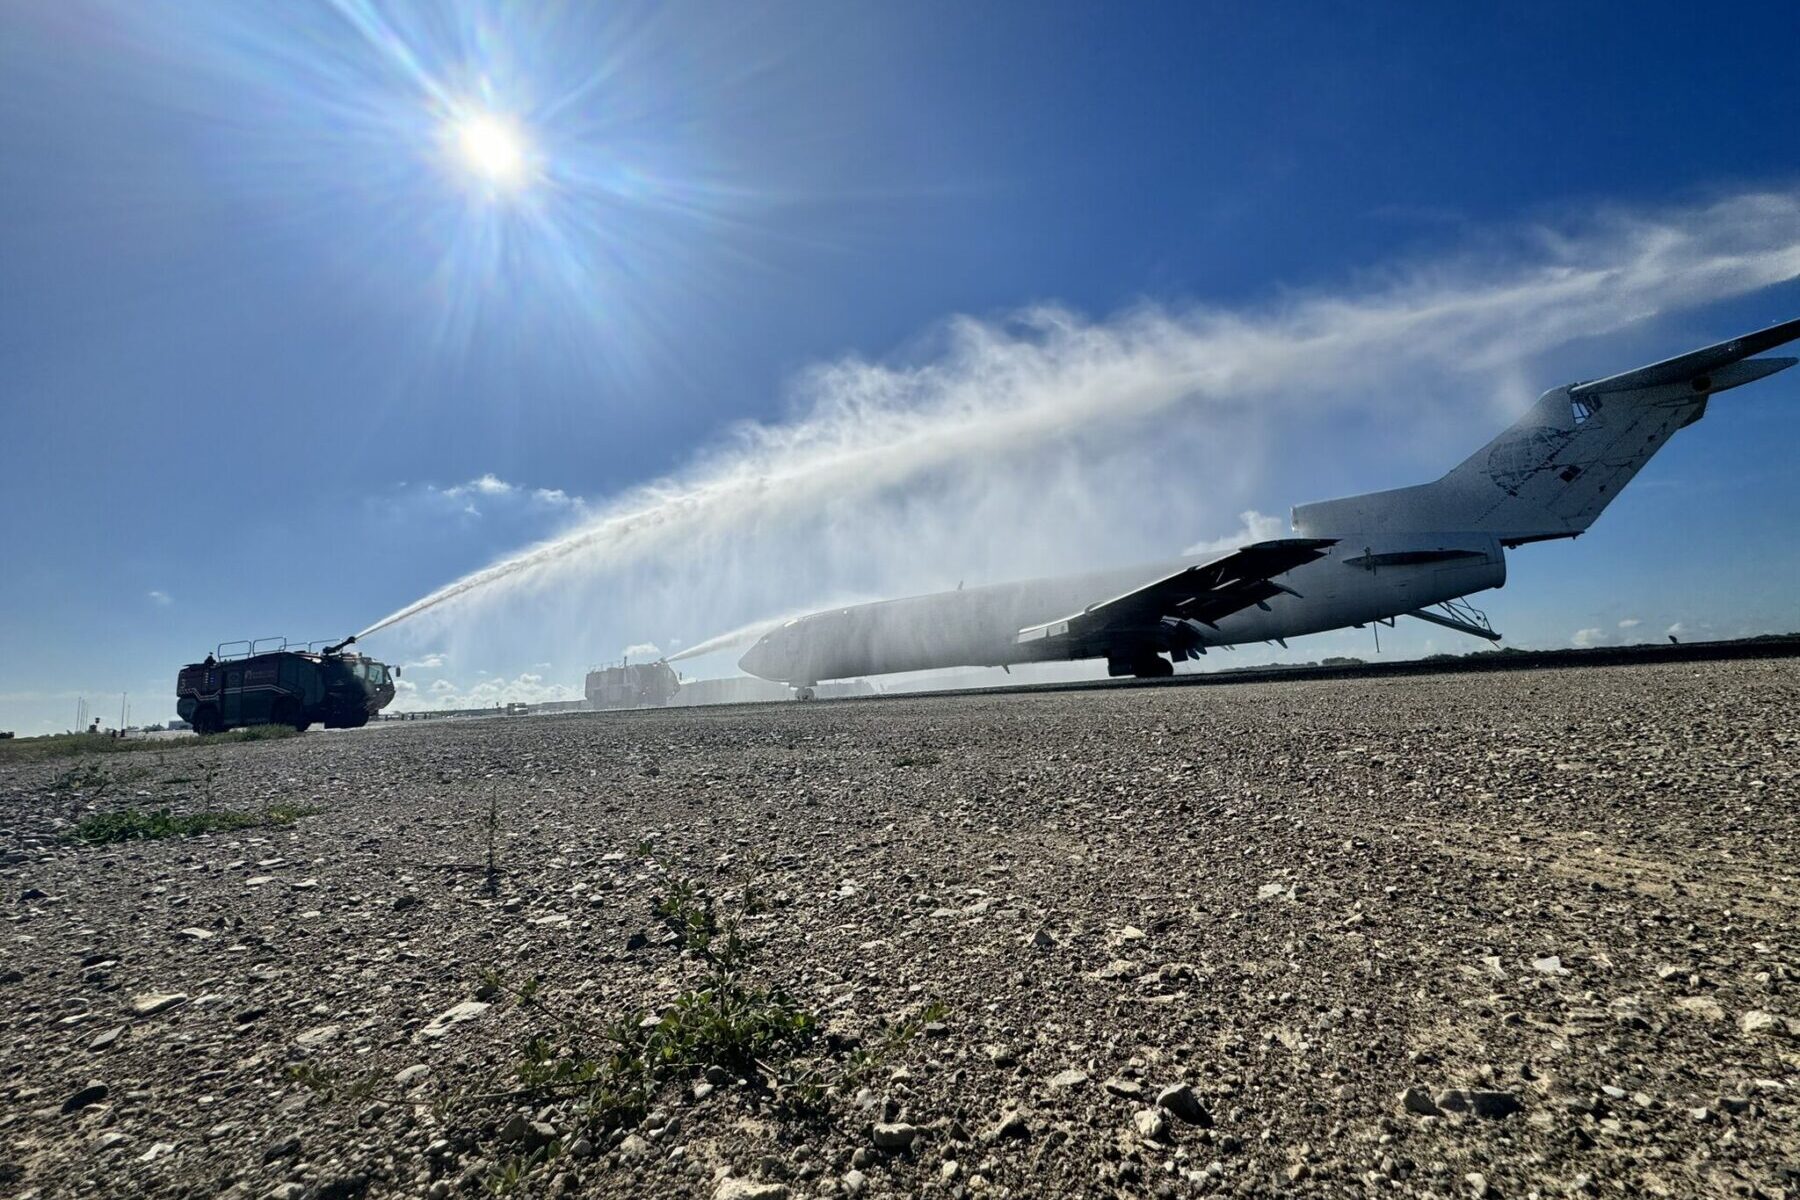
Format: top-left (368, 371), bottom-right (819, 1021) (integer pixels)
top-left (358, 193), bottom-right (1800, 658)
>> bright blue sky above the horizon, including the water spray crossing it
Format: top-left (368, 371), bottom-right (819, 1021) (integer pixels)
top-left (0, 0), bottom-right (1800, 732)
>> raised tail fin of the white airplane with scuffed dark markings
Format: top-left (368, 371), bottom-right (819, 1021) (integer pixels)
top-left (1294, 320), bottom-right (1800, 545)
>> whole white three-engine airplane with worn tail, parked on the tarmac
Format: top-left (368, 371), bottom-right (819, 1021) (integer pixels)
top-left (738, 318), bottom-right (1800, 700)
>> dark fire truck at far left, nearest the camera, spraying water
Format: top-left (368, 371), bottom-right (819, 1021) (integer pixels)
top-left (175, 637), bottom-right (400, 734)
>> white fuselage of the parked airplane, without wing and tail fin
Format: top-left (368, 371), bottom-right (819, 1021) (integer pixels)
top-left (740, 534), bottom-right (1507, 685)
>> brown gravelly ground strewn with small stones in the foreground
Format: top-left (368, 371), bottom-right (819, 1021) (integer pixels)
top-left (0, 660), bottom-right (1800, 1200)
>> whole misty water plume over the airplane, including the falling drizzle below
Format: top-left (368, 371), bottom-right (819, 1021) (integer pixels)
top-left (365, 193), bottom-right (1800, 672)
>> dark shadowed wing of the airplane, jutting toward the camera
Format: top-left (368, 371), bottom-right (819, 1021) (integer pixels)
top-left (1015, 538), bottom-right (1336, 642)
